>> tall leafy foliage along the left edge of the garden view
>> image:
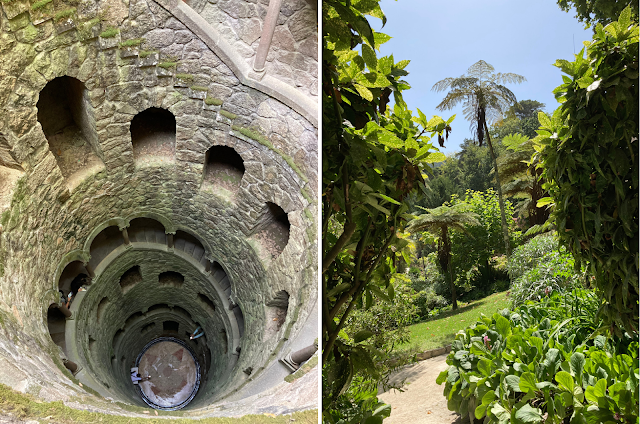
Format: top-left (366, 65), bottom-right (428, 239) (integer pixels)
top-left (322, 0), bottom-right (453, 423)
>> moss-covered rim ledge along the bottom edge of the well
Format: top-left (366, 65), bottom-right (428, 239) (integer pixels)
top-left (0, 384), bottom-right (318, 424)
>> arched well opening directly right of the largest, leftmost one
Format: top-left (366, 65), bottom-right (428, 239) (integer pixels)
top-left (131, 107), bottom-right (176, 164)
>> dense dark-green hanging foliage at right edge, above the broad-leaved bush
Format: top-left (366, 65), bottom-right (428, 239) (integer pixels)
top-left (534, 8), bottom-right (639, 334)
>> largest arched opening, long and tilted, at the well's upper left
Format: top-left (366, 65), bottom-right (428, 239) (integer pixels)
top-left (36, 76), bottom-right (104, 187)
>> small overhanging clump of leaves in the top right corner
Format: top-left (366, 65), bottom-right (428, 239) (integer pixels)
top-left (557, 0), bottom-right (638, 25)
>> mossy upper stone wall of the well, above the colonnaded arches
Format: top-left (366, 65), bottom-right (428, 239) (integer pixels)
top-left (0, 0), bottom-right (318, 416)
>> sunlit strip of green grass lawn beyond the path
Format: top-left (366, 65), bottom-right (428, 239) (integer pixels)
top-left (399, 292), bottom-right (509, 352)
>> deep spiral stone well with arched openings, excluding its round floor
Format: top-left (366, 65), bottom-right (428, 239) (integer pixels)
top-left (0, 0), bottom-right (318, 417)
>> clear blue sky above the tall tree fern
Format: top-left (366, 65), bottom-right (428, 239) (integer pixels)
top-left (370, 0), bottom-right (592, 154)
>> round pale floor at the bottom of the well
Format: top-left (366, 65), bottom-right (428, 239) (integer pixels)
top-left (136, 337), bottom-right (200, 410)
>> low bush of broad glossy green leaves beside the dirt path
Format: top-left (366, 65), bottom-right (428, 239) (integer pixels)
top-left (437, 290), bottom-right (639, 424)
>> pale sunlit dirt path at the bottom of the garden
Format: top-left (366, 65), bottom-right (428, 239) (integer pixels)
top-left (378, 355), bottom-right (468, 424)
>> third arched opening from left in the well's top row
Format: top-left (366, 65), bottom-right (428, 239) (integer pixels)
top-left (202, 146), bottom-right (244, 197)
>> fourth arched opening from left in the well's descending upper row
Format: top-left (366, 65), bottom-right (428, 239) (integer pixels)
top-left (252, 202), bottom-right (291, 259)
